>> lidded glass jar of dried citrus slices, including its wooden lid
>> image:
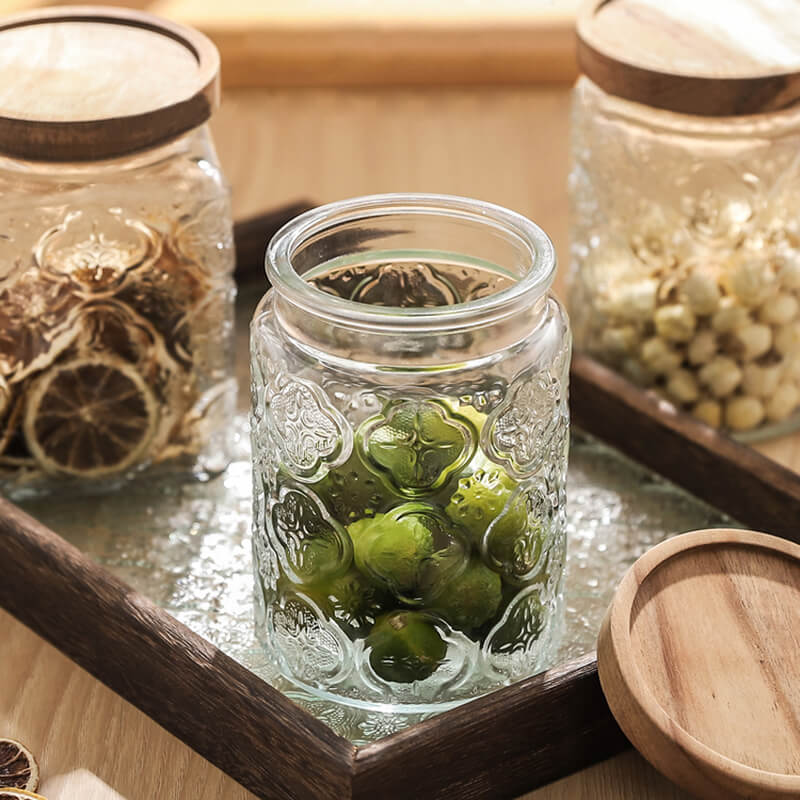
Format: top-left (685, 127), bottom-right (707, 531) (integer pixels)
top-left (0, 7), bottom-right (235, 494)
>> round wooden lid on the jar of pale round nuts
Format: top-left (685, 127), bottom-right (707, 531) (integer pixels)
top-left (578, 0), bottom-right (800, 116)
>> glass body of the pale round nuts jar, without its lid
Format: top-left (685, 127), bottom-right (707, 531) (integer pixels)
top-left (569, 77), bottom-right (800, 438)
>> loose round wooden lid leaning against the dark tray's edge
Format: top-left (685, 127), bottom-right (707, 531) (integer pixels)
top-left (597, 530), bottom-right (800, 800)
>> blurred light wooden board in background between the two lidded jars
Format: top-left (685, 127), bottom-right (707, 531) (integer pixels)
top-left (0, 0), bottom-right (579, 88)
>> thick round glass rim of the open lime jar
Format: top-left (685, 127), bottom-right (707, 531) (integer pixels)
top-left (265, 193), bottom-right (557, 331)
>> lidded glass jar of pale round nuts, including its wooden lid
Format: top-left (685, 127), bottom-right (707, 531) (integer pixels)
top-left (570, 0), bottom-right (800, 438)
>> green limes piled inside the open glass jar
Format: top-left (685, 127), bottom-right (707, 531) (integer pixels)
top-left (276, 400), bottom-right (552, 683)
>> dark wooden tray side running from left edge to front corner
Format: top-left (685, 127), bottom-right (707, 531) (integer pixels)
top-left (0, 500), bottom-right (353, 800)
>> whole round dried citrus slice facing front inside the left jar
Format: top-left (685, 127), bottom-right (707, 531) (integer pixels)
top-left (23, 355), bottom-right (158, 478)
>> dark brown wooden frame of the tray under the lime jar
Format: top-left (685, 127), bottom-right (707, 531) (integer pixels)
top-left (0, 209), bottom-right (800, 800)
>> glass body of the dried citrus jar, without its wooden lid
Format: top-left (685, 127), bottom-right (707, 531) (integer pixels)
top-left (0, 126), bottom-right (236, 494)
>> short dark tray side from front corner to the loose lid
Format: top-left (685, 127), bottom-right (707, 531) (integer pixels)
top-left (353, 654), bottom-right (628, 800)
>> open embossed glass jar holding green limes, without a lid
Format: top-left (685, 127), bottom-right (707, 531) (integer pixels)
top-left (251, 194), bottom-right (570, 712)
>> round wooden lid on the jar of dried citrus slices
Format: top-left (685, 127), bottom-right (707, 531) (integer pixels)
top-left (0, 6), bottom-right (219, 161)
